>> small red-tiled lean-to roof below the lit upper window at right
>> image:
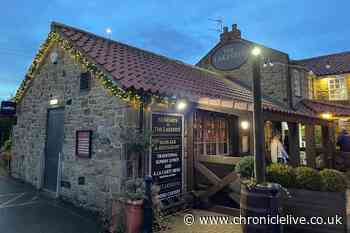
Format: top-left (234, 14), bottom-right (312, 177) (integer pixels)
top-left (301, 99), bottom-right (350, 116)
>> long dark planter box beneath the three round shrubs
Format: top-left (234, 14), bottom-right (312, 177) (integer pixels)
top-left (283, 189), bottom-right (347, 233)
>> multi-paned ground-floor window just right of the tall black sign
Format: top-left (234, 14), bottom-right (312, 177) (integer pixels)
top-left (194, 112), bottom-right (229, 155)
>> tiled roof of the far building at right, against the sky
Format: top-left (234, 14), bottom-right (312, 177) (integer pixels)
top-left (294, 52), bottom-right (350, 76)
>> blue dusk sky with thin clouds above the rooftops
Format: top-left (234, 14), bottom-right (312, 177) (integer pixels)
top-left (0, 0), bottom-right (350, 99)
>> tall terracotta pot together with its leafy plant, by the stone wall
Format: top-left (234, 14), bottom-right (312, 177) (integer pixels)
top-left (114, 178), bottom-right (145, 233)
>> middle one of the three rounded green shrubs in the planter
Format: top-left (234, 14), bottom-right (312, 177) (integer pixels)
top-left (294, 167), bottom-right (322, 191)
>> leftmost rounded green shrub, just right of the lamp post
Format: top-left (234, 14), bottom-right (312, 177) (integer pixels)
top-left (266, 163), bottom-right (296, 188)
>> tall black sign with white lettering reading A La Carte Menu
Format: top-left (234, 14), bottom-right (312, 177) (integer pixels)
top-left (151, 113), bottom-right (182, 200)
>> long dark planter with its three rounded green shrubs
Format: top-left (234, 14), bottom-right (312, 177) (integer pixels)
top-left (267, 164), bottom-right (347, 233)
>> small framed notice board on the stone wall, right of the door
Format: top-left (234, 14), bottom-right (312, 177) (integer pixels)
top-left (75, 130), bottom-right (92, 158)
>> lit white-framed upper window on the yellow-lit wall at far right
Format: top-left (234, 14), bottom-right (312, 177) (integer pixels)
top-left (328, 75), bottom-right (348, 100)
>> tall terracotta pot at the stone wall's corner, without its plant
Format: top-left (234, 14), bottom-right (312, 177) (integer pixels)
top-left (124, 200), bottom-right (143, 233)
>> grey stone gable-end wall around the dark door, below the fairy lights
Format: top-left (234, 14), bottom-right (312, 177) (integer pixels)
top-left (12, 42), bottom-right (138, 210)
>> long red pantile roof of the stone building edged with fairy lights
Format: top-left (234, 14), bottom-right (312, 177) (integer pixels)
top-left (52, 23), bottom-right (312, 116)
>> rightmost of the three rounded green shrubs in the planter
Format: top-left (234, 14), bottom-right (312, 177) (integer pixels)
top-left (320, 169), bottom-right (347, 192)
